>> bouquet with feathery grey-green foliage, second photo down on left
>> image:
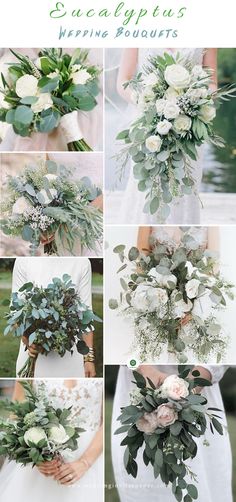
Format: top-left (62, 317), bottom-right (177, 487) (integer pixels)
top-left (0, 161), bottom-right (103, 255)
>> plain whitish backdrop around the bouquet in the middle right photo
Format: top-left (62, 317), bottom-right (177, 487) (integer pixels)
top-left (104, 226), bottom-right (236, 364)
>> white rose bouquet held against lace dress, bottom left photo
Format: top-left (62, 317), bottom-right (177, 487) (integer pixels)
top-left (0, 382), bottom-right (84, 467)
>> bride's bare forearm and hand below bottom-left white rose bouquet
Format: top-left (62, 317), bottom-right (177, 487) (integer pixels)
top-left (54, 425), bottom-right (103, 485)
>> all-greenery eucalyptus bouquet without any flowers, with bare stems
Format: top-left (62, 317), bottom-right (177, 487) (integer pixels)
top-left (4, 274), bottom-right (101, 378)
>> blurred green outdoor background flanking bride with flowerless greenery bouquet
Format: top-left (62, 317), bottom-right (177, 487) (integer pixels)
top-left (0, 258), bottom-right (103, 378)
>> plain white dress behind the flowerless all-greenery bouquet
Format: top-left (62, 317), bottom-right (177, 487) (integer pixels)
top-left (12, 257), bottom-right (92, 378)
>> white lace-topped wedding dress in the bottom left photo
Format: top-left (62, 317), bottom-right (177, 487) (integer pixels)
top-left (0, 379), bottom-right (103, 502)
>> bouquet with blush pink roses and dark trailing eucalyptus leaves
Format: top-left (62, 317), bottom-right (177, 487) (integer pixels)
top-left (115, 366), bottom-right (223, 502)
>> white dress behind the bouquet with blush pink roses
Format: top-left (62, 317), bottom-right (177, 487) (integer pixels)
top-left (112, 365), bottom-right (233, 502)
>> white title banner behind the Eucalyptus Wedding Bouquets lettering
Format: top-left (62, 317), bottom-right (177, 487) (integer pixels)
top-left (0, 0), bottom-right (236, 47)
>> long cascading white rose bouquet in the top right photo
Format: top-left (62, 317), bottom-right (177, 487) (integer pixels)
top-left (117, 54), bottom-right (236, 222)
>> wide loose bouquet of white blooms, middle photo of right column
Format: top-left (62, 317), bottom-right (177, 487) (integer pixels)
top-left (109, 227), bottom-right (234, 364)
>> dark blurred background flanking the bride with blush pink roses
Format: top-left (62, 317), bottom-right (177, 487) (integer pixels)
top-left (105, 366), bottom-right (236, 502)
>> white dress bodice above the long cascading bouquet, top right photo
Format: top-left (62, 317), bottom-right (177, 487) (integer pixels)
top-left (138, 47), bottom-right (204, 69)
